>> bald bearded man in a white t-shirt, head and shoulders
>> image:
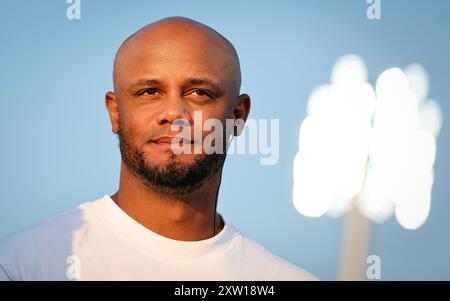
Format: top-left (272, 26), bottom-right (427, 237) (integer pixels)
top-left (0, 17), bottom-right (315, 280)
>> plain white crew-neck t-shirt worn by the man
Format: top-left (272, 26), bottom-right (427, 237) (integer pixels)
top-left (0, 195), bottom-right (316, 280)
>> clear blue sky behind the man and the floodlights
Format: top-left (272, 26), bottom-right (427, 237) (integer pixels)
top-left (0, 0), bottom-right (450, 280)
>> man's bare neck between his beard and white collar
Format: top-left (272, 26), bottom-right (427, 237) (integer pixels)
top-left (111, 164), bottom-right (224, 241)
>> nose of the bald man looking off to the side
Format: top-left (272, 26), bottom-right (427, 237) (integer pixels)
top-left (157, 95), bottom-right (192, 125)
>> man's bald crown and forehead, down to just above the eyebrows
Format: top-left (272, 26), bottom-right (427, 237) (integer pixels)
top-left (114, 18), bottom-right (240, 94)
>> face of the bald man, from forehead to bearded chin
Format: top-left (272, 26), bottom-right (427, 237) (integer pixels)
top-left (110, 26), bottom-right (238, 193)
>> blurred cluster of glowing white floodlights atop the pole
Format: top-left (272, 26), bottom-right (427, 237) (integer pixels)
top-left (293, 55), bottom-right (442, 229)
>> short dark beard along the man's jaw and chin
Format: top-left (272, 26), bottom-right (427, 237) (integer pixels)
top-left (118, 127), bottom-right (226, 195)
